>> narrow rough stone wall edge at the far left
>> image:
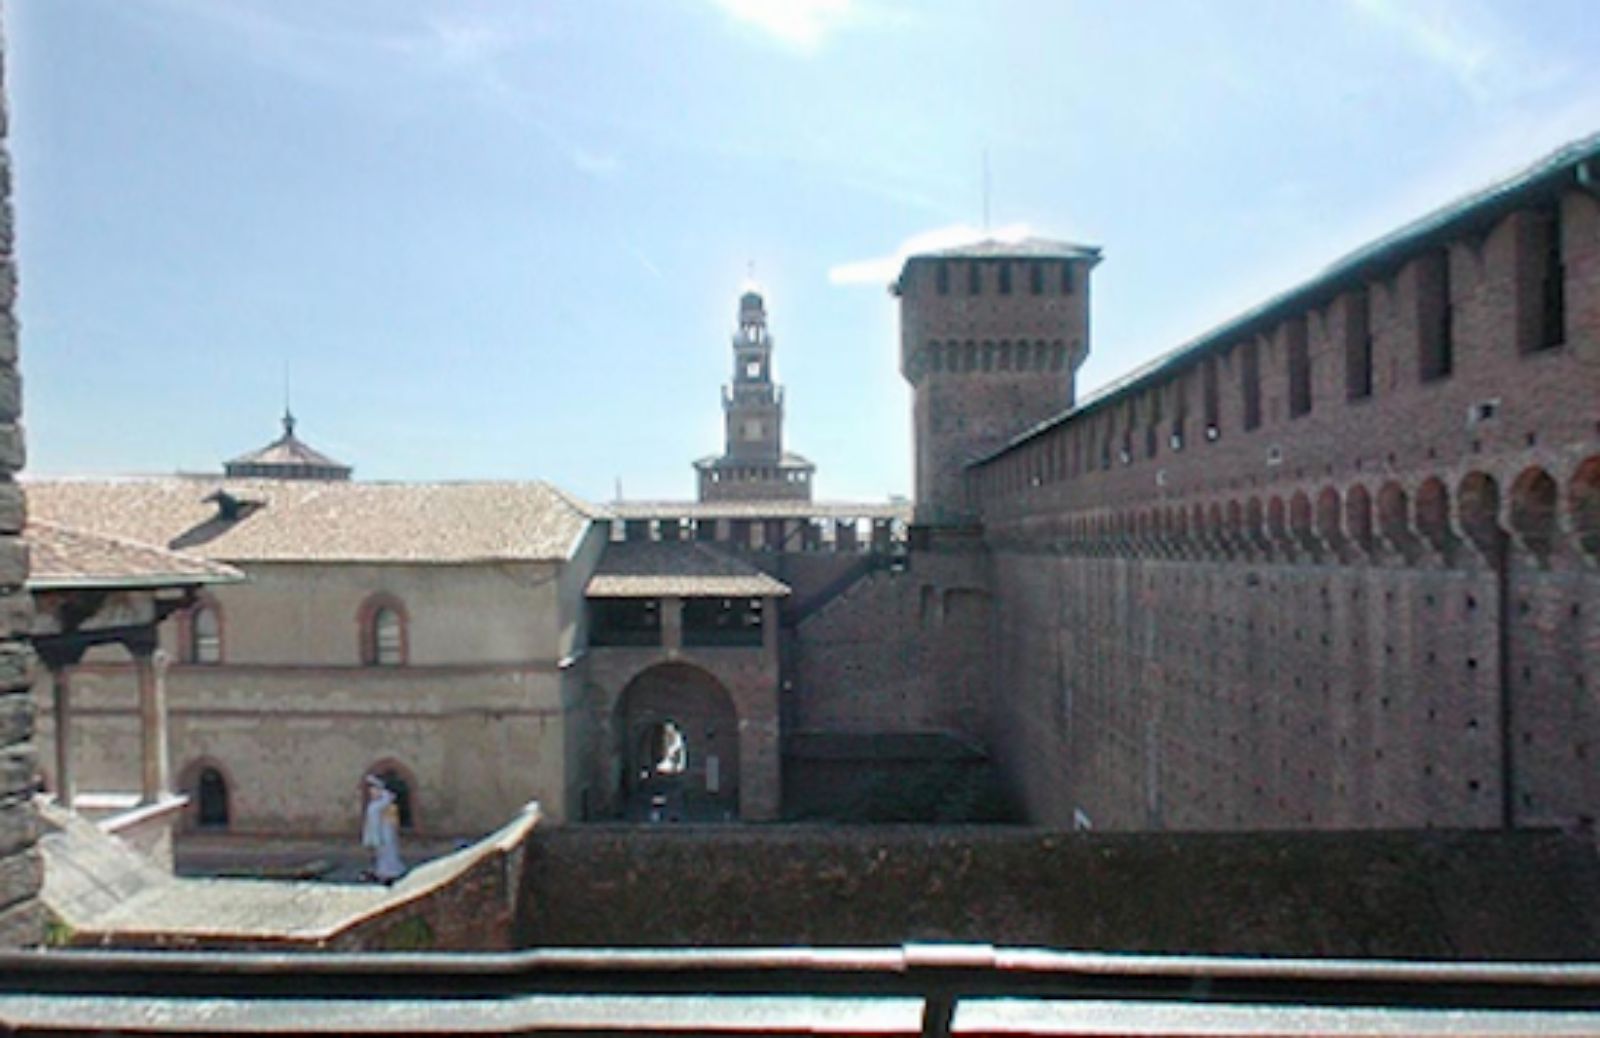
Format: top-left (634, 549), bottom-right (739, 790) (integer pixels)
top-left (0, 8), bottom-right (43, 945)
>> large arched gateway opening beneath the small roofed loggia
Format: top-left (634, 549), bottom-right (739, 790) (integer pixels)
top-left (613, 662), bottom-right (739, 822)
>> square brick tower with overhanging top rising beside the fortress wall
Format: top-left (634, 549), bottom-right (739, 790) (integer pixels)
top-left (890, 238), bottom-right (1099, 525)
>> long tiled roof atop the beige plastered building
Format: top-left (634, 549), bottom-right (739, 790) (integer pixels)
top-left (26, 477), bottom-right (603, 563)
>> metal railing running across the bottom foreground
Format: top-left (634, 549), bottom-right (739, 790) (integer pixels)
top-left (0, 945), bottom-right (1600, 1038)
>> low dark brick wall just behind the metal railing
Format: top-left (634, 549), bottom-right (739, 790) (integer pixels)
top-left (517, 827), bottom-right (1600, 960)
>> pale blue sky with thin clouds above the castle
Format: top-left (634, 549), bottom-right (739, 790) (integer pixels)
top-left (6, 0), bottom-right (1600, 501)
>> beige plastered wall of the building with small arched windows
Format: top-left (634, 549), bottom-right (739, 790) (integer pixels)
top-left (38, 543), bottom-right (602, 836)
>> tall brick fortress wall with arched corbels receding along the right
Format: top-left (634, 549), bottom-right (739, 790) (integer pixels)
top-left (970, 189), bottom-right (1600, 828)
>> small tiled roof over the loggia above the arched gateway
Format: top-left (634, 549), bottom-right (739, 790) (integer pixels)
top-left (584, 541), bottom-right (789, 598)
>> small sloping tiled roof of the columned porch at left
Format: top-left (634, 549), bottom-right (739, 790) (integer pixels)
top-left (22, 518), bottom-right (243, 590)
